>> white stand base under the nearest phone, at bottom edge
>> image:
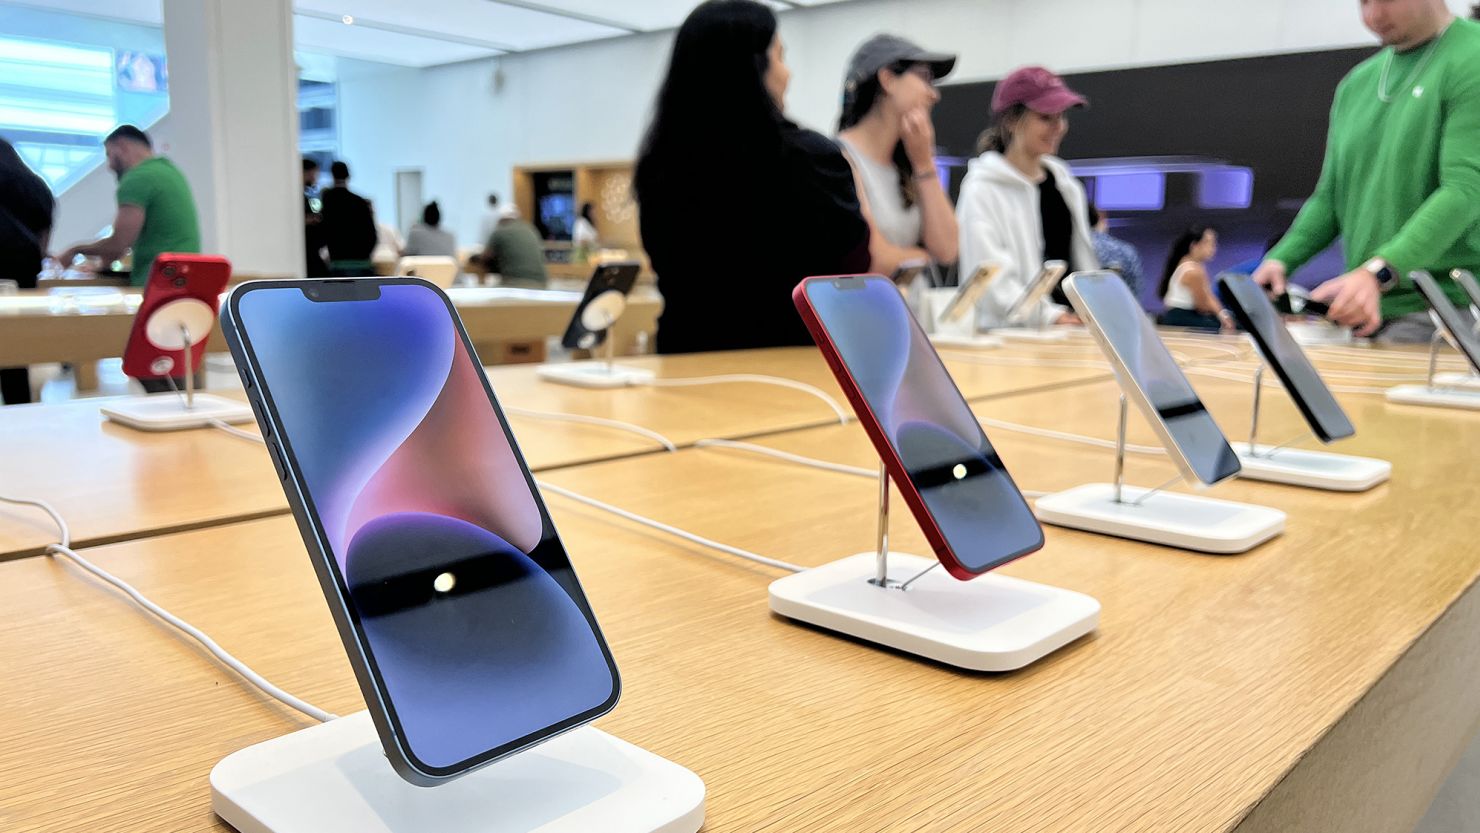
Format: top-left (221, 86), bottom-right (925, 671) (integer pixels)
top-left (210, 712), bottom-right (704, 833)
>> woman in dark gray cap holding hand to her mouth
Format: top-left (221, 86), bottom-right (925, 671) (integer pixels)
top-left (838, 34), bottom-right (958, 275)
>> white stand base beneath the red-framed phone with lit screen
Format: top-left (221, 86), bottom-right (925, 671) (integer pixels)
top-left (770, 552), bottom-right (1100, 672)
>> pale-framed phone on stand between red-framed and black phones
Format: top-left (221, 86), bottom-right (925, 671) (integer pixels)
top-left (1066, 272), bottom-right (1240, 484)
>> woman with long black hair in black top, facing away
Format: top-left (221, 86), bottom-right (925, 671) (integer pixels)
top-left (633, 0), bottom-right (869, 354)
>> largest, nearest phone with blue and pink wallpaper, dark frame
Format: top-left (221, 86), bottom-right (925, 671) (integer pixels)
top-left (232, 278), bottom-right (620, 775)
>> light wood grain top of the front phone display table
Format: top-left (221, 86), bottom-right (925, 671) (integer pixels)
top-left (0, 363), bottom-right (1480, 833)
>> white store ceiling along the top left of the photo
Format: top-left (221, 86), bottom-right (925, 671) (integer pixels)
top-left (0, 0), bottom-right (845, 67)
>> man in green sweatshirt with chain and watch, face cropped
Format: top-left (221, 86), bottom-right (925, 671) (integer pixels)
top-left (1254, 0), bottom-right (1480, 342)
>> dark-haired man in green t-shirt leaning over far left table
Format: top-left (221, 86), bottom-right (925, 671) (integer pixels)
top-left (59, 124), bottom-right (200, 287)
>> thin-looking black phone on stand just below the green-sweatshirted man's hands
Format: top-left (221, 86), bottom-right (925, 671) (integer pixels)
top-left (1221, 275), bottom-right (1356, 442)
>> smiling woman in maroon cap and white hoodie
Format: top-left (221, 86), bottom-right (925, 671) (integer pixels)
top-left (956, 67), bottom-right (1100, 328)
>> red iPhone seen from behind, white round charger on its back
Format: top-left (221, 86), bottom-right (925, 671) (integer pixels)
top-left (123, 254), bottom-right (231, 379)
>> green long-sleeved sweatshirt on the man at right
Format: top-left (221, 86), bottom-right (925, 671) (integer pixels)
top-left (1268, 19), bottom-right (1480, 318)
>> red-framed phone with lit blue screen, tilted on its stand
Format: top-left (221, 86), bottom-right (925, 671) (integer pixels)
top-left (805, 277), bottom-right (1043, 573)
